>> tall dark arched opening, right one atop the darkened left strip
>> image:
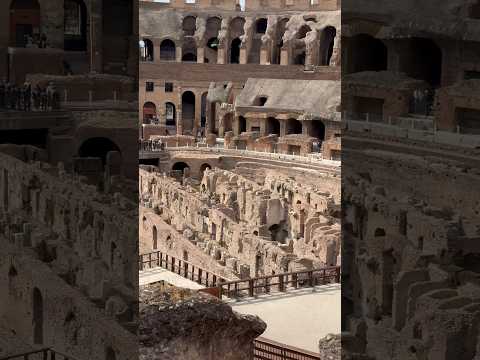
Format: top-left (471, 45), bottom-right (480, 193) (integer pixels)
top-left (63, 0), bottom-right (87, 51)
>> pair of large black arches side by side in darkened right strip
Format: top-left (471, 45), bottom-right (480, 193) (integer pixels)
top-left (345, 34), bottom-right (442, 87)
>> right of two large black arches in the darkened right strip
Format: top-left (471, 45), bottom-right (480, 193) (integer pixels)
top-left (400, 38), bottom-right (442, 87)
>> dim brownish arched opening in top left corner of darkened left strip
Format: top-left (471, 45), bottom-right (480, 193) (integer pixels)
top-left (10, 0), bottom-right (40, 47)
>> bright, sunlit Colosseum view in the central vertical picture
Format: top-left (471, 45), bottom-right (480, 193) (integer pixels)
top-left (139, 0), bottom-right (341, 360)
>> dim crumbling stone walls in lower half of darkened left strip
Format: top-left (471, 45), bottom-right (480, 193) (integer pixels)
top-left (0, 154), bottom-right (138, 359)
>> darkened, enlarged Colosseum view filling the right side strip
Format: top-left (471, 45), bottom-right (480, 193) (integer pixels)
top-left (342, 0), bottom-right (480, 360)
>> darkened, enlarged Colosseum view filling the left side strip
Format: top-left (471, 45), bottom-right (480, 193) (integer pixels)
top-left (0, 0), bottom-right (138, 360)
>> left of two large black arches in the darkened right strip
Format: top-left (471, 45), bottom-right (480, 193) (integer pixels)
top-left (347, 34), bottom-right (388, 73)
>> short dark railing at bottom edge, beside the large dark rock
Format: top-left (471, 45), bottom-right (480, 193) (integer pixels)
top-left (253, 337), bottom-right (320, 360)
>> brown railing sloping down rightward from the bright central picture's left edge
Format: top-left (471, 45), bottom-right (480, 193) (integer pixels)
top-left (138, 251), bottom-right (228, 287)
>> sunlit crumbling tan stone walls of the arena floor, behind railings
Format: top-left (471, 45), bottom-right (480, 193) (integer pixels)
top-left (139, 160), bottom-right (340, 278)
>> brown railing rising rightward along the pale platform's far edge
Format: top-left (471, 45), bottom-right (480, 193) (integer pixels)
top-left (217, 266), bottom-right (340, 299)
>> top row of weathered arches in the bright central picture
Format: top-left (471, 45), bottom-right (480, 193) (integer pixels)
top-left (141, 16), bottom-right (337, 66)
